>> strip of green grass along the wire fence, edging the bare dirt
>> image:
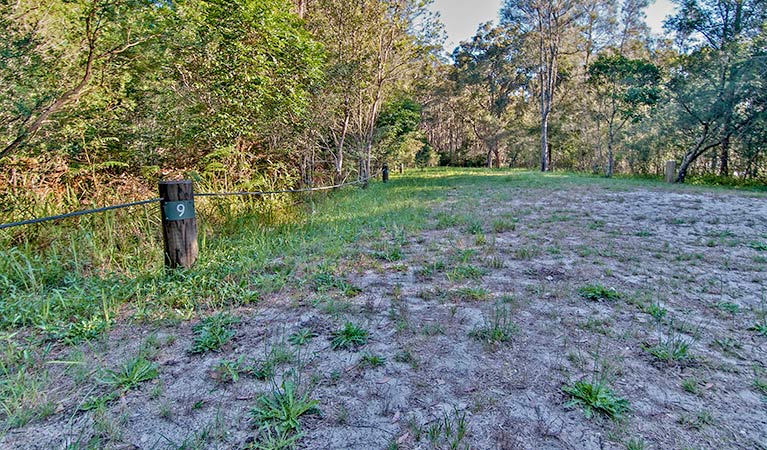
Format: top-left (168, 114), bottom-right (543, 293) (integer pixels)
top-left (0, 168), bottom-right (756, 341)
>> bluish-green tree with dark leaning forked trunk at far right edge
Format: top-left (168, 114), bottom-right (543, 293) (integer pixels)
top-left (666, 0), bottom-right (767, 182)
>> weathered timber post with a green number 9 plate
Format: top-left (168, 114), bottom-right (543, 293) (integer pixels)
top-left (160, 180), bottom-right (198, 269)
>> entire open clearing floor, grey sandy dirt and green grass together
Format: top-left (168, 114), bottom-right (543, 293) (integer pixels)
top-left (0, 169), bottom-right (767, 449)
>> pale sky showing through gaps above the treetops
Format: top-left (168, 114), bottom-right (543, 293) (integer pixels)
top-left (431, 0), bottom-right (674, 52)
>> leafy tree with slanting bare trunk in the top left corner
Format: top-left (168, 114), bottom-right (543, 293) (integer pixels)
top-left (0, 0), bottom-right (168, 162)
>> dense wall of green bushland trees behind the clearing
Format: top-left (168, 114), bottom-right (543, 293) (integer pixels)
top-left (0, 0), bottom-right (767, 222)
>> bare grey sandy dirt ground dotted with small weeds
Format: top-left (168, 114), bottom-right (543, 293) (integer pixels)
top-left (0, 171), bottom-right (767, 449)
